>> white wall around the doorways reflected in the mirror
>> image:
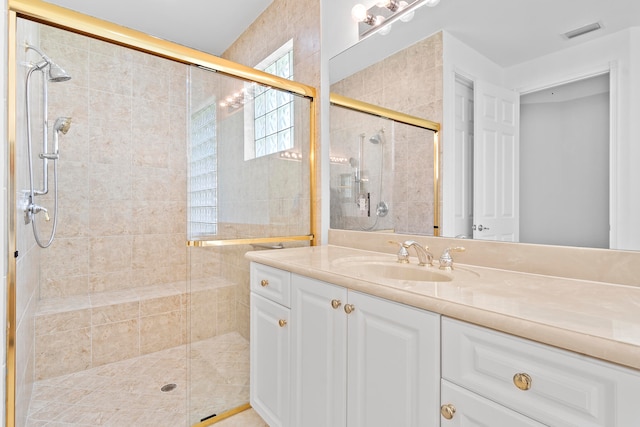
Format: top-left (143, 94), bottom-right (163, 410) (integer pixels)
top-left (442, 28), bottom-right (640, 250)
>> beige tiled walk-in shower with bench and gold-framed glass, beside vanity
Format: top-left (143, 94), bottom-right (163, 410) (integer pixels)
top-left (7, 1), bottom-right (313, 426)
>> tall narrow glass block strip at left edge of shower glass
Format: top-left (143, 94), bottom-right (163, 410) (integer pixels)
top-left (188, 102), bottom-right (218, 240)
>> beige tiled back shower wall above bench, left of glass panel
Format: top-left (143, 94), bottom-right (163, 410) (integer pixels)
top-left (40, 27), bottom-right (187, 299)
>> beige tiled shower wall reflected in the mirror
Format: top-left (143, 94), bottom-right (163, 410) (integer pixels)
top-left (331, 33), bottom-right (443, 234)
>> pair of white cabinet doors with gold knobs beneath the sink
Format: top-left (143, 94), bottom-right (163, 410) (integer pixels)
top-left (291, 274), bottom-right (440, 427)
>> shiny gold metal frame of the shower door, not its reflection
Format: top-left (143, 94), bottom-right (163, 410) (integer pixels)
top-left (5, 0), bottom-right (319, 427)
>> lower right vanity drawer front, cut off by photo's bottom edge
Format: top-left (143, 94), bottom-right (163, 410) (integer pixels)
top-left (440, 380), bottom-right (544, 427)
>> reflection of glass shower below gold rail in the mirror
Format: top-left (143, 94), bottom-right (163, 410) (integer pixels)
top-left (330, 101), bottom-right (438, 235)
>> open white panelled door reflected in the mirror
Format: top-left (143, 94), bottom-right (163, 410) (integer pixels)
top-left (473, 81), bottom-right (520, 242)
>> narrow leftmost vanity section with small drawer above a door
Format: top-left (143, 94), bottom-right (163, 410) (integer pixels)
top-left (250, 263), bottom-right (291, 427)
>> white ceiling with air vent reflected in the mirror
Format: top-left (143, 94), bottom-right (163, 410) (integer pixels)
top-left (428, 0), bottom-right (640, 67)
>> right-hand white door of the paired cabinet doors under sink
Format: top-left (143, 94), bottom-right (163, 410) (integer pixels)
top-left (347, 292), bottom-right (440, 427)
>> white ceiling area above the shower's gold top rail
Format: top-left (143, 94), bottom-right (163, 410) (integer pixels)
top-left (48, 0), bottom-right (273, 56)
